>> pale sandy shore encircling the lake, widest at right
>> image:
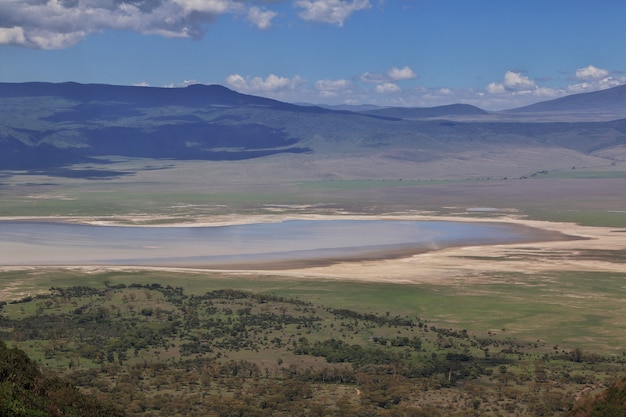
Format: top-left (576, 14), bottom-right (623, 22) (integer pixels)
top-left (0, 214), bottom-right (626, 284)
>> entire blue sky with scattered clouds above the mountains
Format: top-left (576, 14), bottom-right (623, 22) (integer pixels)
top-left (0, 0), bottom-right (626, 110)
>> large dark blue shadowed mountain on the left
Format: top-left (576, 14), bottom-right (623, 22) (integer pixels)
top-left (0, 82), bottom-right (320, 169)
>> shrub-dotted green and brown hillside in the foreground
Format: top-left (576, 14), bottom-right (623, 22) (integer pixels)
top-left (0, 275), bottom-right (625, 417)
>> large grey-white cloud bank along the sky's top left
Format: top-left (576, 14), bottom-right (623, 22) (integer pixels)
top-left (0, 0), bottom-right (276, 49)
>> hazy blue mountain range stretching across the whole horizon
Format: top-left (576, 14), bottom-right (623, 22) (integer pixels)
top-left (0, 82), bottom-right (626, 177)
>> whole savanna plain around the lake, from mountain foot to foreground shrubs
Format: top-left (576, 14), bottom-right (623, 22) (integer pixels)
top-left (0, 155), bottom-right (626, 416)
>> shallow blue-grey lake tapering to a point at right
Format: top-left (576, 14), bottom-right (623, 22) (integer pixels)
top-left (0, 220), bottom-right (554, 268)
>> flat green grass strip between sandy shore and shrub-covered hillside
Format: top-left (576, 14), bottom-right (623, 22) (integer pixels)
top-left (0, 271), bottom-right (626, 353)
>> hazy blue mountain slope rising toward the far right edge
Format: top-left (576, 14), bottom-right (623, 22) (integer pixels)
top-left (502, 84), bottom-right (626, 118)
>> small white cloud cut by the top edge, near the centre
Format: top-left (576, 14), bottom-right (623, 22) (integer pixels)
top-left (294, 0), bottom-right (371, 26)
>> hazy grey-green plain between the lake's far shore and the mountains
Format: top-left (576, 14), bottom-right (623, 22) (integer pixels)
top-left (0, 165), bottom-right (626, 227)
